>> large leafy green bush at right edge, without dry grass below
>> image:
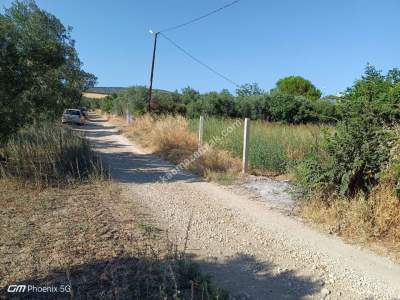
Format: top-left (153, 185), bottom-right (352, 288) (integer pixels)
top-left (297, 65), bottom-right (400, 198)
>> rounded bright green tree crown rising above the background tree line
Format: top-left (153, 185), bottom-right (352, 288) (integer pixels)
top-left (272, 76), bottom-right (321, 100)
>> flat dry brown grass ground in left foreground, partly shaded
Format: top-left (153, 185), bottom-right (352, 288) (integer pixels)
top-left (0, 179), bottom-right (225, 299)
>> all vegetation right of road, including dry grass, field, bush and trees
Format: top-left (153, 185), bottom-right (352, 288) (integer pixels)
top-left (96, 65), bottom-right (400, 254)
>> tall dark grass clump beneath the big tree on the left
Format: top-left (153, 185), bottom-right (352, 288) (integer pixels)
top-left (0, 123), bottom-right (106, 187)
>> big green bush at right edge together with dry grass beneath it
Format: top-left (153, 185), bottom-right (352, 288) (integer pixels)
top-left (297, 66), bottom-right (400, 253)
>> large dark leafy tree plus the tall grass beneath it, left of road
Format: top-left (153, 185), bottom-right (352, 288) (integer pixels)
top-left (0, 1), bottom-right (104, 188)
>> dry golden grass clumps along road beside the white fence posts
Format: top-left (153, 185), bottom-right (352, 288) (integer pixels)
top-left (115, 115), bottom-right (241, 180)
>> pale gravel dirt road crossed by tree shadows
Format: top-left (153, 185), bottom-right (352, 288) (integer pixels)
top-left (83, 114), bottom-right (400, 299)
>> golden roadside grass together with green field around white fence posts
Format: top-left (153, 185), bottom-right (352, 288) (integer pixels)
top-left (108, 115), bottom-right (322, 182)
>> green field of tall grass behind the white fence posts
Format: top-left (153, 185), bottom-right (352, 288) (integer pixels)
top-left (189, 118), bottom-right (329, 173)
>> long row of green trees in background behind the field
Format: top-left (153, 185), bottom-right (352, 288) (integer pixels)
top-left (89, 76), bottom-right (338, 124)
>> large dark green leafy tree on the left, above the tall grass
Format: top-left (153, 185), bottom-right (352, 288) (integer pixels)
top-left (0, 1), bottom-right (96, 140)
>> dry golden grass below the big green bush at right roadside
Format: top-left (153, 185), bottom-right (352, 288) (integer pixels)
top-left (301, 182), bottom-right (400, 261)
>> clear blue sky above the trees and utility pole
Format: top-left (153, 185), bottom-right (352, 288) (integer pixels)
top-left (0, 0), bottom-right (400, 95)
